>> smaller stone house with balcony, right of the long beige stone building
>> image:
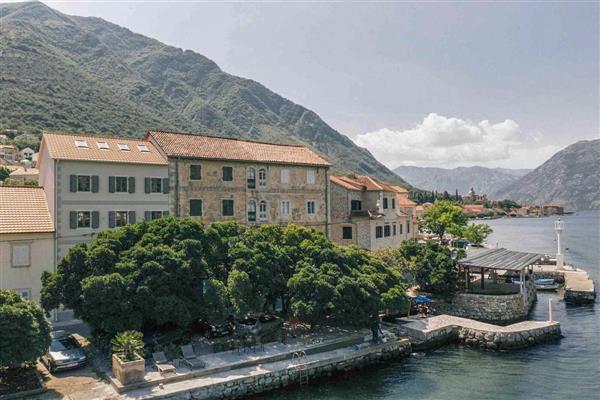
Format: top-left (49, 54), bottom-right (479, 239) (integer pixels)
top-left (330, 174), bottom-right (418, 250)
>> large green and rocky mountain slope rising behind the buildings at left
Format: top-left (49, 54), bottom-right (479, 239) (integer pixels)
top-left (0, 2), bottom-right (406, 185)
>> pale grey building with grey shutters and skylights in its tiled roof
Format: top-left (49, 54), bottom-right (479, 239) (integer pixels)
top-left (38, 133), bottom-right (169, 261)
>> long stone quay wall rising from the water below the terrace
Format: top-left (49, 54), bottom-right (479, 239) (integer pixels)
top-left (153, 339), bottom-right (411, 400)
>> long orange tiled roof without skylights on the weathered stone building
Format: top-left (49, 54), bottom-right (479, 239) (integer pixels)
top-left (146, 131), bottom-right (331, 167)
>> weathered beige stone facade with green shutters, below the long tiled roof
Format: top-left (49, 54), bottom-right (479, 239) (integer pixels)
top-left (169, 159), bottom-right (329, 233)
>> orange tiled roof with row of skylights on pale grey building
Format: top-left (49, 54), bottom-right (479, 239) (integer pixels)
top-left (42, 132), bottom-right (168, 165)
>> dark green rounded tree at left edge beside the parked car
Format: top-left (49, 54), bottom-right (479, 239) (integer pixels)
top-left (0, 290), bottom-right (51, 368)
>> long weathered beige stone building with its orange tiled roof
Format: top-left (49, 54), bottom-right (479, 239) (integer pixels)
top-left (146, 131), bottom-right (330, 233)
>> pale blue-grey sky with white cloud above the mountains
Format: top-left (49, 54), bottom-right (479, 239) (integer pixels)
top-left (34, 1), bottom-right (600, 168)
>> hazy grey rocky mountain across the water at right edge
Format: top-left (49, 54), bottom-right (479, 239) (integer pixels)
top-left (499, 139), bottom-right (600, 210)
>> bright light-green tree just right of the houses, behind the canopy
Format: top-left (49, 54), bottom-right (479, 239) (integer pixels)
top-left (421, 200), bottom-right (468, 240)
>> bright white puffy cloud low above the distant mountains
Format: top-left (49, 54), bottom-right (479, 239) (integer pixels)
top-left (354, 113), bottom-right (561, 168)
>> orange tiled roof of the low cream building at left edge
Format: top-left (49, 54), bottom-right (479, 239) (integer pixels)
top-left (0, 186), bottom-right (54, 234)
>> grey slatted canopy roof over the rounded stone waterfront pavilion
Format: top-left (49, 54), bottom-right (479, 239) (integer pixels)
top-left (458, 248), bottom-right (542, 271)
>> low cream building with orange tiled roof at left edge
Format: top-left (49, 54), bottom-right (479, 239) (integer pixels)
top-left (0, 186), bottom-right (54, 303)
